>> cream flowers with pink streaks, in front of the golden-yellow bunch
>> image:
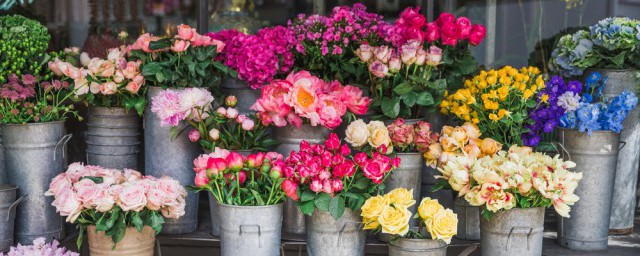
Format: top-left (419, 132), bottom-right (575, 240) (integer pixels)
top-left (437, 145), bottom-right (582, 219)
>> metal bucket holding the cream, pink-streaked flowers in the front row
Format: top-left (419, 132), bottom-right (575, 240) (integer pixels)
top-left (480, 207), bottom-right (544, 256)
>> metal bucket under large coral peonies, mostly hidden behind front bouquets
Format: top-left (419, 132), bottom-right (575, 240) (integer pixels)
top-left (273, 124), bottom-right (331, 240)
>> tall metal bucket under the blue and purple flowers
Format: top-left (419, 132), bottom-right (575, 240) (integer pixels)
top-left (557, 129), bottom-right (620, 251)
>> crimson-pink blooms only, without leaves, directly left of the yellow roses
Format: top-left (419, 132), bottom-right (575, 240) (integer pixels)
top-left (282, 133), bottom-right (400, 200)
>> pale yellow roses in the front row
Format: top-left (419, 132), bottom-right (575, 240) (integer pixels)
top-left (361, 188), bottom-right (458, 244)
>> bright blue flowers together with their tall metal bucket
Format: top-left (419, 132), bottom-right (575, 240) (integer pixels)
top-left (558, 73), bottom-right (638, 251)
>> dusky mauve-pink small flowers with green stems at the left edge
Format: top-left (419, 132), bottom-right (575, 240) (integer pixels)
top-left (0, 73), bottom-right (82, 124)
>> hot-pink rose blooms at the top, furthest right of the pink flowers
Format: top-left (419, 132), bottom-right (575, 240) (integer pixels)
top-left (385, 7), bottom-right (486, 47)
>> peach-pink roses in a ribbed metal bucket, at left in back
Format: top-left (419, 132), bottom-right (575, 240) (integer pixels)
top-left (49, 46), bottom-right (147, 169)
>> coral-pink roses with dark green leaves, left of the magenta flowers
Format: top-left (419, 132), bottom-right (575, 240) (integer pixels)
top-left (127, 25), bottom-right (235, 91)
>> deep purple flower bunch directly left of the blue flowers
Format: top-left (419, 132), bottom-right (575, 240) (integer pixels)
top-left (522, 76), bottom-right (582, 147)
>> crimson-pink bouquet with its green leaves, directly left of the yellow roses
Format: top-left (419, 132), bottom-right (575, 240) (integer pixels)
top-left (282, 133), bottom-right (400, 220)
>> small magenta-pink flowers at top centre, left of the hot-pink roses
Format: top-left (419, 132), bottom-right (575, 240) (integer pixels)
top-left (288, 3), bottom-right (390, 56)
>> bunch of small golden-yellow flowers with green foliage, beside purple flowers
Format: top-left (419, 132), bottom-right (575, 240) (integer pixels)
top-left (440, 66), bottom-right (545, 146)
